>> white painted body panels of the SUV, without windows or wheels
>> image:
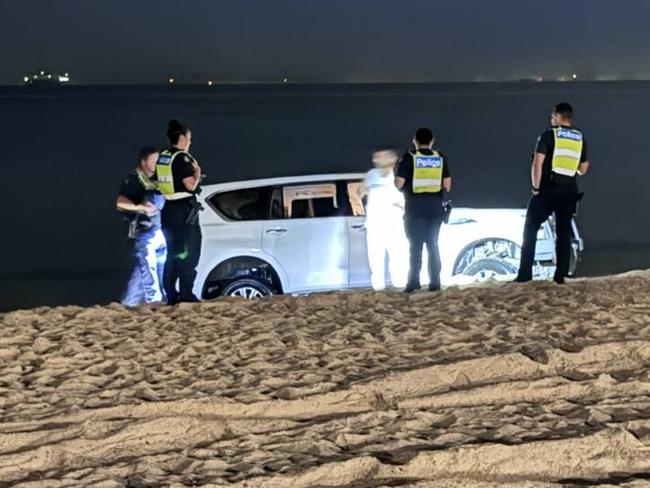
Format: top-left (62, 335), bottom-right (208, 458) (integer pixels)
top-left (194, 173), bottom-right (555, 296)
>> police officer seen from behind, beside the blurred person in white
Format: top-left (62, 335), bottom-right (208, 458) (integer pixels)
top-left (395, 128), bottom-right (451, 293)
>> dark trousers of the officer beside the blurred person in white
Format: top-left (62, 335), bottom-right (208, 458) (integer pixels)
top-left (404, 215), bottom-right (443, 289)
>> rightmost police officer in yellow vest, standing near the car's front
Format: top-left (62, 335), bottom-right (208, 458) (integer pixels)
top-left (515, 103), bottom-right (589, 284)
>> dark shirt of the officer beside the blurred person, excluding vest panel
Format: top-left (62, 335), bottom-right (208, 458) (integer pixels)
top-left (397, 149), bottom-right (451, 219)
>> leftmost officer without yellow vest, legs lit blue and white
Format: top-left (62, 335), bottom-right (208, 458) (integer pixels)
top-left (117, 147), bottom-right (167, 307)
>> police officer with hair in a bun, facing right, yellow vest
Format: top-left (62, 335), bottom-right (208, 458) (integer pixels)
top-left (156, 120), bottom-right (201, 305)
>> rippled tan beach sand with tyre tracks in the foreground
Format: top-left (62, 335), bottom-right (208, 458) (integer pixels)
top-left (0, 272), bottom-right (650, 488)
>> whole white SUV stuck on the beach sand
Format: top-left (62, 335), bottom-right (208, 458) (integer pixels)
top-left (195, 174), bottom-right (583, 299)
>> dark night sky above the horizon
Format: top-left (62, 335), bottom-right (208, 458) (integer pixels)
top-left (0, 0), bottom-right (650, 84)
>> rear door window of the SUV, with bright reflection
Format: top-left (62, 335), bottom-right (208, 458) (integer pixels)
top-left (282, 183), bottom-right (340, 219)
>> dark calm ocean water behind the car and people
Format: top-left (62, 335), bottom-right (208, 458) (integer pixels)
top-left (0, 82), bottom-right (650, 310)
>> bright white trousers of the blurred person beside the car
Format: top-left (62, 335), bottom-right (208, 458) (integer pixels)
top-left (366, 216), bottom-right (409, 290)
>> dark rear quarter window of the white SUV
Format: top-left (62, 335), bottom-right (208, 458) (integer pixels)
top-left (208, 187), bottom-right (271, 221)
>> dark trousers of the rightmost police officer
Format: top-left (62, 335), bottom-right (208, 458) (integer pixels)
top-left (517, 184), bottom-right (578, 282)
